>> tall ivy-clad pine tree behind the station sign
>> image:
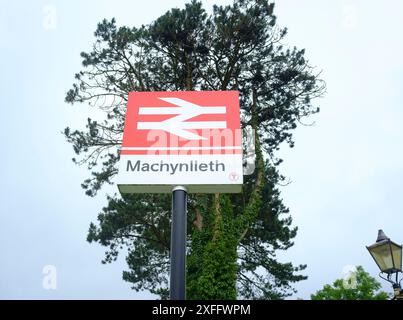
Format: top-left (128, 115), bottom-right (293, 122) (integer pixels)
top-left (64, 0), bottom-right (325, 299)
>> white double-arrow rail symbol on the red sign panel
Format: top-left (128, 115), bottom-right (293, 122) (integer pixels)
top-left (137, 98), bottom-right (227, 140)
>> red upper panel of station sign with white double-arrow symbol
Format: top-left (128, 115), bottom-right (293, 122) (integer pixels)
top-left (121, 91), bottom-right (241, 155)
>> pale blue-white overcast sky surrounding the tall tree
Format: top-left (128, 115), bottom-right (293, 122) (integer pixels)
top-left (0, 0), bottom-right (403, 299)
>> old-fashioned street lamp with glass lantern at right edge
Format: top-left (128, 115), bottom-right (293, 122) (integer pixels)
top-left (367, 230), bottom-right (403, 299)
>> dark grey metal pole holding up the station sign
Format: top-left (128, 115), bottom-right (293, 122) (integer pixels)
top-left (170, 186), bottom-right (187, 300)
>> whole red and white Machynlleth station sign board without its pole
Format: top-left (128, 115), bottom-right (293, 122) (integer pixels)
top-left (118, 91), bottom-right (243, 193)
